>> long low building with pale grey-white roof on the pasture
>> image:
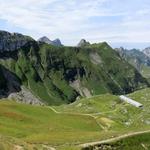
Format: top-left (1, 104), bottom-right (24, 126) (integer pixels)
top-left (119, 95), bottom-right (143, 107)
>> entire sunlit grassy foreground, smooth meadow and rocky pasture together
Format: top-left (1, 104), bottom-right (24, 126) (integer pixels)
top-left (0, 89), bottom-right (150, 150)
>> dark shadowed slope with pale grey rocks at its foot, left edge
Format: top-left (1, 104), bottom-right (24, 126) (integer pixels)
top-left (0, 65), bottom-right (43, 105)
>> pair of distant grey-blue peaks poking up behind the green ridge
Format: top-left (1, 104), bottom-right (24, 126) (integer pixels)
top-left (38, 36), bottom-right (63, 46)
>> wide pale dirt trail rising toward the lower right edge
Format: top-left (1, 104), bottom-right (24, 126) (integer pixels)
top-left (79, 130), bottom-right (150, 148)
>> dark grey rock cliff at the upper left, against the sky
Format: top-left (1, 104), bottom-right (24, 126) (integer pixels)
top-left (0, 31), bottom-right (33, 52)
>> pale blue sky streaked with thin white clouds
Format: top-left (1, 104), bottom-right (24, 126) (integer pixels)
top-left (0, 0), bottom-right (150, 48)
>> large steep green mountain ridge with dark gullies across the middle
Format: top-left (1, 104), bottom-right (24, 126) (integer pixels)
top-left (0, 30), bottom-right (149, 105)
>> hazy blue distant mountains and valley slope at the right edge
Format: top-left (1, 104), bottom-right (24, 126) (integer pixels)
top-left (115, 47), bottom-right (150, 78)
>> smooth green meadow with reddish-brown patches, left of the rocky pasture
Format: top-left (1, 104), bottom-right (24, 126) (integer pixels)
top-left (0, 101), bottom-right (102, 145)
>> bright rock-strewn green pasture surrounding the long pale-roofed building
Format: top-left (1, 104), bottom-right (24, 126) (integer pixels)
top-left (54, 89), bottom-right (150, 148)
